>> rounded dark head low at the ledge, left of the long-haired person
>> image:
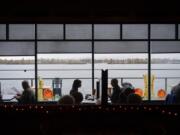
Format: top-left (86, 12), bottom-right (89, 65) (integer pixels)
top-left (58, 95), bottom-right (75, 105)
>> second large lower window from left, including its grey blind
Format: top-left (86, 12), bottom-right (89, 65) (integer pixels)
top-left (38, 41), bottom-right (92, 101)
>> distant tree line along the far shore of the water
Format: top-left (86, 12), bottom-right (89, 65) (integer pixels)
top-left (0, 58), bottom-right (180, 64)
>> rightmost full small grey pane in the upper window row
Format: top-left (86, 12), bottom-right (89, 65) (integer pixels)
top-left (151, 24), bottom-right (175, 39)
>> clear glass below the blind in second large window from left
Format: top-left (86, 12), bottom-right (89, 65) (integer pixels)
top-left (38, 53), bottom-right (92, 101)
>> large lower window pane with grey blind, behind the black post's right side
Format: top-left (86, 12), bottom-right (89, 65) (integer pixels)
top-left (94, 41), bottom-right (148, 103)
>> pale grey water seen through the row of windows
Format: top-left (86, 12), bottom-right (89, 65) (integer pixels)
top-left (0, 63), bottom-right (180, 99)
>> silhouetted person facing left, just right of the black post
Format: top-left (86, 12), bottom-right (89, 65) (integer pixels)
top-left (110, 78), bottom-right (122, 104)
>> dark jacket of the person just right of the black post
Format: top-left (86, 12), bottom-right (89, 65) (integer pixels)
top-left (110, 86), bottom-right (122, 104)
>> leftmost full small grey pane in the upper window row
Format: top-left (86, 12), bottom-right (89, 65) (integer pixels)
top-left (9, 24), bottom-right (35, 39)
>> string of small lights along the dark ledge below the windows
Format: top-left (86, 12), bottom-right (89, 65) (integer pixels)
top-left (0, 104), bottom-right (178, 117)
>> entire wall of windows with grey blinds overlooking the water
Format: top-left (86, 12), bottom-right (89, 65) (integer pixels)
top-left (0, 24), bottom-right (180, 104)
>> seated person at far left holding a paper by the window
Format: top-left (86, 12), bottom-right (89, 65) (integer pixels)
top-left (15, 81), bottom-right (35, 104)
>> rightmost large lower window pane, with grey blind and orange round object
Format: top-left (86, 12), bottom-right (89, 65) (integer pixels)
top-left (151, 41), bottom-right (180, 100)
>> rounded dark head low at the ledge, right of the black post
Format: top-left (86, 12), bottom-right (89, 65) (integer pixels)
top-left (127, 93), bottom-right (142, 104)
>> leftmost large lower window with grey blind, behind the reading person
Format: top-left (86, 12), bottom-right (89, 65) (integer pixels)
top-left (0, 42), bottom-right (35, 101)
